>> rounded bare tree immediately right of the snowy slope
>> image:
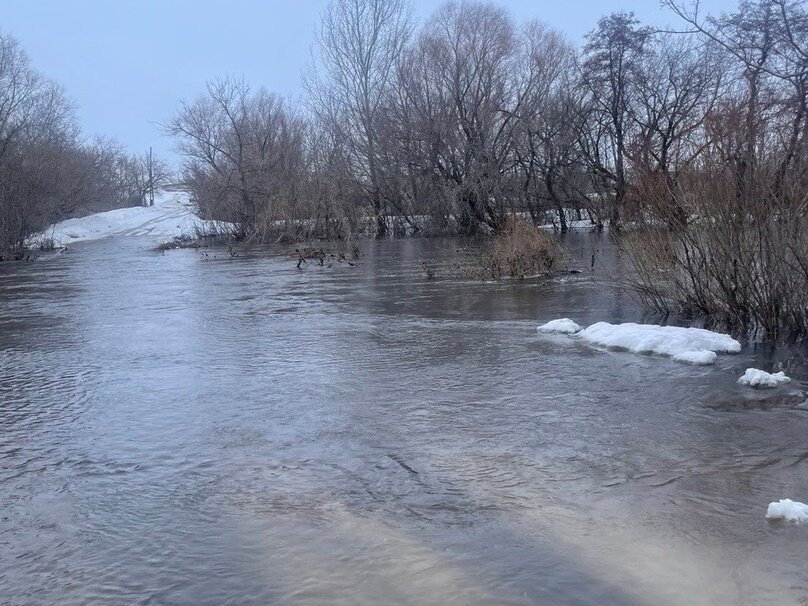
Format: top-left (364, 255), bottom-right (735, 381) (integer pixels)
top-left (166, 79), bottom-right (309, 240)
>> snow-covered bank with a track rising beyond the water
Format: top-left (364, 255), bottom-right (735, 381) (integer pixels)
top-left (30, 191), bottom-right (226, 246)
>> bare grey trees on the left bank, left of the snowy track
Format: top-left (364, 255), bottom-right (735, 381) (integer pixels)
top-left (0, 34), bottom-right (168, 252)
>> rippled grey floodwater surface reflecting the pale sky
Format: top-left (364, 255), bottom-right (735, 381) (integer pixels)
top-left (0, 235), bottom-right (808, 604)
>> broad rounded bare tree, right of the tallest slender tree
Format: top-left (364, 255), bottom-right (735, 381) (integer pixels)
top-left (392, 3), bottom-right (521, 234)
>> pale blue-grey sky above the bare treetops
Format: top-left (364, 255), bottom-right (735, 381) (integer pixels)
top-left (0, 0), bottom-right (736, 159)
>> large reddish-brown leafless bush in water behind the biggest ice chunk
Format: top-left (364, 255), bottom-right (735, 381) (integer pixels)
top-left (622, 168), bottom-right (808, 339)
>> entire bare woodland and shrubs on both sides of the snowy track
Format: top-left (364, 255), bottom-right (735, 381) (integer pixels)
top-left (0, 0), bottom-right (808, 335)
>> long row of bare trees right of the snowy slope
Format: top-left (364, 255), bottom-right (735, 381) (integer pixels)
top-left (167, 0), bottom-right (808, 245)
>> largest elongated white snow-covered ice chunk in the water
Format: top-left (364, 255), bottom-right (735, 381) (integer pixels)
top-left (578, 322), bottom-right (741, 364)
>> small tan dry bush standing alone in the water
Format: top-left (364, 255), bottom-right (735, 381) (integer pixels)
top-left (482, 217), bottom-right (566, 279)
